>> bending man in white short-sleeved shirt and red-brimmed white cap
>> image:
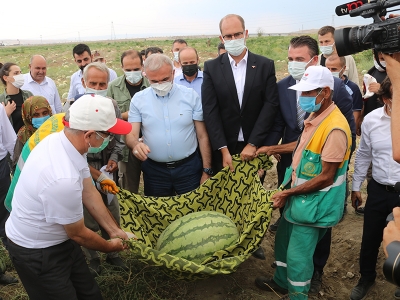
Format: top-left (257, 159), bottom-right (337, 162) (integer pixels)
top-left (6, 95), bottom-right (132, 300)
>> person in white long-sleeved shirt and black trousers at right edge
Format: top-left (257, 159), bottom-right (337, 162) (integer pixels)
top-left (350, 77), bottom-right (400, 300)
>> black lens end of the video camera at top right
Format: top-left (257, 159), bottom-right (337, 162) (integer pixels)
top-left (335, 26), bottom-right (372, 56)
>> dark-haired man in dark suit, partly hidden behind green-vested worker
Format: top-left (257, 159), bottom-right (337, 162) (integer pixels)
top-left (265, 36), bottom-right (356, 294)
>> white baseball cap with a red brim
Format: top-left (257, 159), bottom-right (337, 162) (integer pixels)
top-left (64, 94), bottom-right (132, 134)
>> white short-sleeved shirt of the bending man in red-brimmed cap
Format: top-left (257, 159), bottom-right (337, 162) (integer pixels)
top-left (6, 131), bottom-right (90, 249)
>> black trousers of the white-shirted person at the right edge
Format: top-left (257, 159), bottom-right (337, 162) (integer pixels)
top-left (360, 178), bottom-right (400, 281)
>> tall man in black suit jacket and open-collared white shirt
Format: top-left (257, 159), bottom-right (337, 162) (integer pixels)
top-left (201, 15), bottom-right (279, 171)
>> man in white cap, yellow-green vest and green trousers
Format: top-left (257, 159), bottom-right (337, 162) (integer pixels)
top-left (256, 66), bottom-right (351, 299)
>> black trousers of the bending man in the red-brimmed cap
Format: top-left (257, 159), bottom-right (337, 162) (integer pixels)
top-left (8, 240), bottom-right (103, 300)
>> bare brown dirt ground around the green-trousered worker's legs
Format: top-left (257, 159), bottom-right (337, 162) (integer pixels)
top-left (184, 151), bottom-right (396, 300)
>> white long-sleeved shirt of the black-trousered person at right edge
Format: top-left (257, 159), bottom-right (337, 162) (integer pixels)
top-left (352, 106), bottom-right (400, 191)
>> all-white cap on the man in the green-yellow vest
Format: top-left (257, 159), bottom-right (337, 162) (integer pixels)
top-left (289, 66), bottom-right (334, 92)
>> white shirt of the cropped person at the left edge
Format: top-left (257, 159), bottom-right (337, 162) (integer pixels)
top-left (0, 104), bottom-right (17, 159)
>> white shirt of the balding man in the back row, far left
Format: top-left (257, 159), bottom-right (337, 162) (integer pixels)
top-left (21, 73), bottom-right (62, 114)
